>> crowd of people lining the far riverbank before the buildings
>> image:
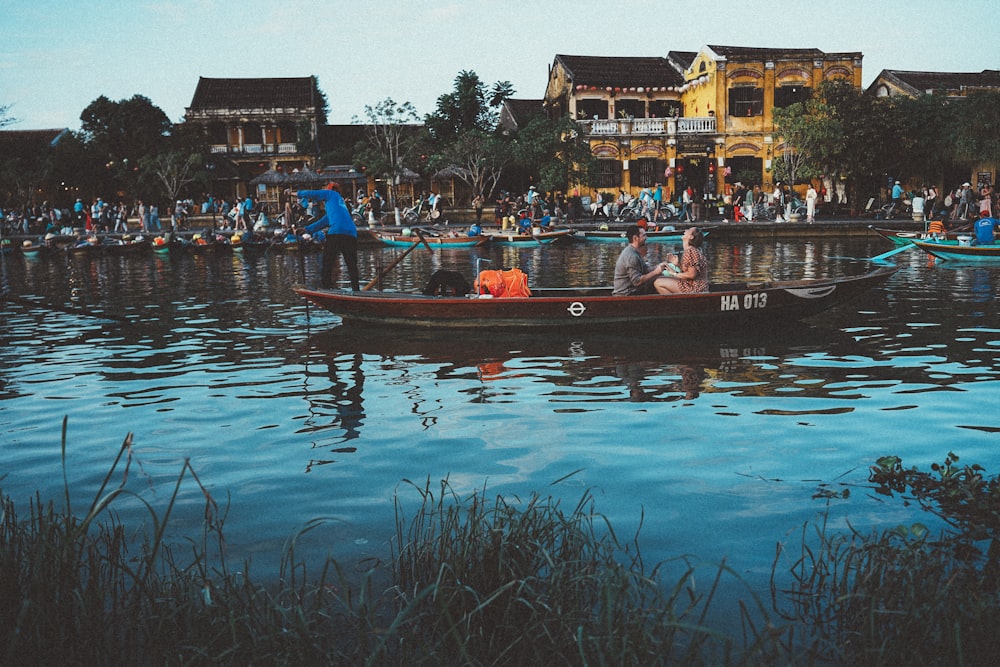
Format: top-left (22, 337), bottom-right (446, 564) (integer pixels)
top-left (0, 177), bottom-right (997, 240)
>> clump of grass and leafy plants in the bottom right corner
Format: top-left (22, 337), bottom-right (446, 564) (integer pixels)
top-left (774, 453), bottom-right (1000, 667)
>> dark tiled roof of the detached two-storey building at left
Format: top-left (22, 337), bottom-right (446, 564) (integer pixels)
top-left (189, 76), bottom-right (322, 110)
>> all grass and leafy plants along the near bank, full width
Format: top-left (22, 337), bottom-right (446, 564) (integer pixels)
top-left (0, 428), bottom-right (1000, 665)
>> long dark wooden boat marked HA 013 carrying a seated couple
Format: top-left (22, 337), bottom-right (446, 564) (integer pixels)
top-left (295, 267), bottom-right (897, 332)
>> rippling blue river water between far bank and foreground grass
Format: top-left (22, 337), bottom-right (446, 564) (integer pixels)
top-left (0, 236), bottom-right (1000, 620)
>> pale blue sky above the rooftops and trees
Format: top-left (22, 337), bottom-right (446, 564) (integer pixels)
top-left (0, 0), bottom-right (1000, 130)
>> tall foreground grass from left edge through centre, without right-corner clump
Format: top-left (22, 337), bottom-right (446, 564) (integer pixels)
top-left (0, 421), bottom-right (787, 665)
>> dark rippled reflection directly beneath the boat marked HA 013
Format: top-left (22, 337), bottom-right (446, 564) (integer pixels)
top-left (310, 323), bottom-right (853, 404)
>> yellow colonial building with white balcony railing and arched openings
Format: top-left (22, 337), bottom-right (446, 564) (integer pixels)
top-left (544, 46), bottom-right (862, 204)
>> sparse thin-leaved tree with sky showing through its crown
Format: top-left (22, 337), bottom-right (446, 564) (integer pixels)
top-left (354, 98), bottom-right (418, 222)
